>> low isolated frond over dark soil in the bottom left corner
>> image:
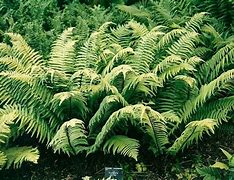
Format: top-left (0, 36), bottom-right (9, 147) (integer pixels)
top-left (3, 146), bottom-right (39, 169)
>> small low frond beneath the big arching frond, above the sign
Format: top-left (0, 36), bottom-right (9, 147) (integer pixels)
top-left (103, 135), bottom-right (140, 161)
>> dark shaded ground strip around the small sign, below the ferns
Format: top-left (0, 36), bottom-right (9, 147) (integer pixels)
top-left (0, 135), bottom-right (234, 180)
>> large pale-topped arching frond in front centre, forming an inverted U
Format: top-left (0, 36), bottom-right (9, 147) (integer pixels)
top-left (88, 104), bottom-right (168, 154)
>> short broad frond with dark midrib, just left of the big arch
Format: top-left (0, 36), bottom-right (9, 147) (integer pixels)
top-left (49, 119), bottom-right (88, 155)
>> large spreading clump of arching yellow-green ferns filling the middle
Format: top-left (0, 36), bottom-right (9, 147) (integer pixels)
top-left (0, 10), bottom-right (234, 165)
